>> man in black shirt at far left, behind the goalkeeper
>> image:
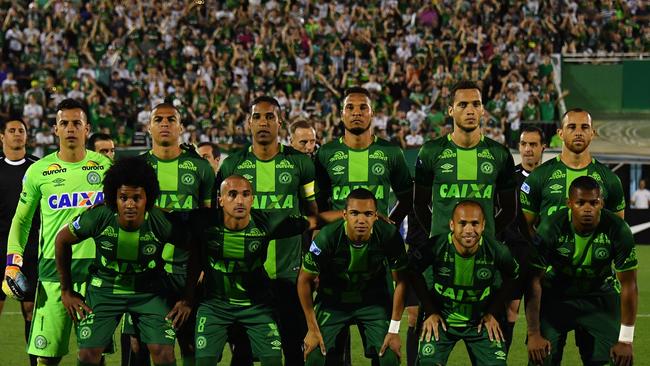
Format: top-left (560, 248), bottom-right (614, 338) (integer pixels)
top-left (0, 120), bottom-right (40, 365)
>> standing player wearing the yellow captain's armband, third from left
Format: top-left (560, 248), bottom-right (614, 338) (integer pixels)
top-left (218, 96), bottom-right (318, 365)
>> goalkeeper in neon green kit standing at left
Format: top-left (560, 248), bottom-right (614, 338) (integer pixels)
top-left (5, 99), bottom-right (110, 365)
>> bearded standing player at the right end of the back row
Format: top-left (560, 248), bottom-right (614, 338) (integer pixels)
top-left (520, 108), bottom-right (625, 362)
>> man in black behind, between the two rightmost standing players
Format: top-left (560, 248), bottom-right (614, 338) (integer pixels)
top-left (501, 126), bottom-right (546, 350)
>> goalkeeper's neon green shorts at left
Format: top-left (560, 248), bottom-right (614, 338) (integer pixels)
top-left (27, 281), bottom-right (86, 357)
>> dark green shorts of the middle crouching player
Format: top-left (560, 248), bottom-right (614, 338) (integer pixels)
top-left (306, 304), bottom-right (399, 365)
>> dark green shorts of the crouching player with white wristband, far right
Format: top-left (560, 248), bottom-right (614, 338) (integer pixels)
top-left (540, 293), bottom-right (621, 365)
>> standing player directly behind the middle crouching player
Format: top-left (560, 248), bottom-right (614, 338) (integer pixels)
top-left (316, 87), bottom-right (413, 363)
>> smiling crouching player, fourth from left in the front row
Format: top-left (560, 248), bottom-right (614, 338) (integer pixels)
top-left (409, 200), bottom-right (519, 365)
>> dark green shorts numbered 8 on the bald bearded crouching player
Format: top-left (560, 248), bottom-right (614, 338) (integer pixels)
top-left (195, 299), bottom-right (282, 359)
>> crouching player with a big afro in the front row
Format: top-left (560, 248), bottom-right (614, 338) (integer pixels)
top-left (56, 158), bottom-right (194, 365)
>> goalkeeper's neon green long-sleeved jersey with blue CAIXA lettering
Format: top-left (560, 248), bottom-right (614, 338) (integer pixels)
top-left (7, 150), bottom-right (111, 282)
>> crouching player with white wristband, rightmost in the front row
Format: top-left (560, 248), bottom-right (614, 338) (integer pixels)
top-left (526, 176), bottom-right (638, 365)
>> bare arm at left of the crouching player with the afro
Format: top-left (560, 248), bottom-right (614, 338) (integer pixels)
top-left (55, 226), bottom-right (92, 321)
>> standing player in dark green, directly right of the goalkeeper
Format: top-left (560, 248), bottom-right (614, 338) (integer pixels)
top-left (143, 103), bottom-right (215, 365)
